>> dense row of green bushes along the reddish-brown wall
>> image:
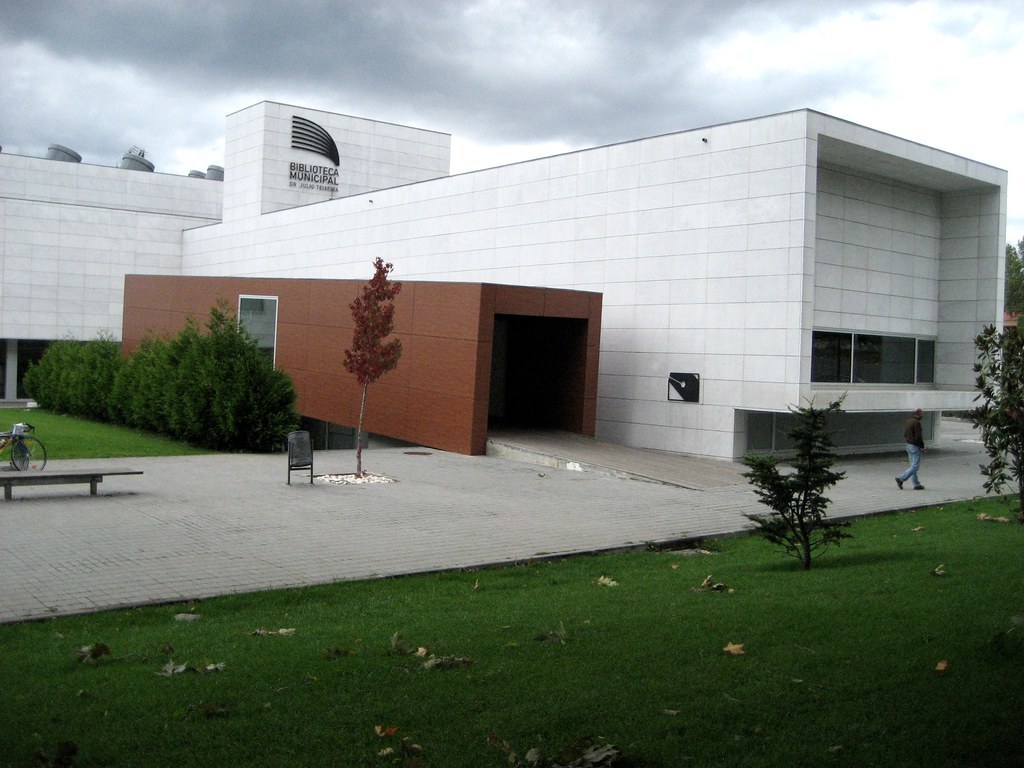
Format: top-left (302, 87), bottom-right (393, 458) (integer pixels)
top-left (26, 306), bottom-right (299, 451)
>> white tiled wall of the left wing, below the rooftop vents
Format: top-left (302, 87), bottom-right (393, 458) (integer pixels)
top-left (0, 155), bottom-right (221, 340)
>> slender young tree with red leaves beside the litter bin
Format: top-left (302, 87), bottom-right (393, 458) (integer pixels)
top-left (345, 256), bottom-right (401, 477)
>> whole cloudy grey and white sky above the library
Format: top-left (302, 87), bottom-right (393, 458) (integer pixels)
top-left (0, 0), bottom-right (1024, 243)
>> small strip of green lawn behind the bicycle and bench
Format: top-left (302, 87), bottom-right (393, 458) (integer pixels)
top-left (0, 408), bottom-right (210, 461)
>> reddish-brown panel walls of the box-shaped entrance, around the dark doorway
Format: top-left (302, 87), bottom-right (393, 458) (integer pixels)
top-left (123, 275), bottom-right (601, 454)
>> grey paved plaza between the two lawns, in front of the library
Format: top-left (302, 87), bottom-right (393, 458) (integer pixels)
top-left (0, 421), bottom-right (985, 622)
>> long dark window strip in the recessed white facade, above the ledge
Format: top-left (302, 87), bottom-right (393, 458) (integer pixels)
top-left (811, 331), bottom-right (935, 384)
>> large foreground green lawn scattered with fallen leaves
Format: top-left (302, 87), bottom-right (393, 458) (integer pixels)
top-left (0, 500), bottom-right (1024, 768)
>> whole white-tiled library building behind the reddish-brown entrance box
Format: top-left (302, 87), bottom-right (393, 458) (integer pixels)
top-left (0, 102), bottom-right (1007, 458)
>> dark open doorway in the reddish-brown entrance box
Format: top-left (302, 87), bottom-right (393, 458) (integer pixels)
top-left (488, 314), bottom-right (587, 433)
